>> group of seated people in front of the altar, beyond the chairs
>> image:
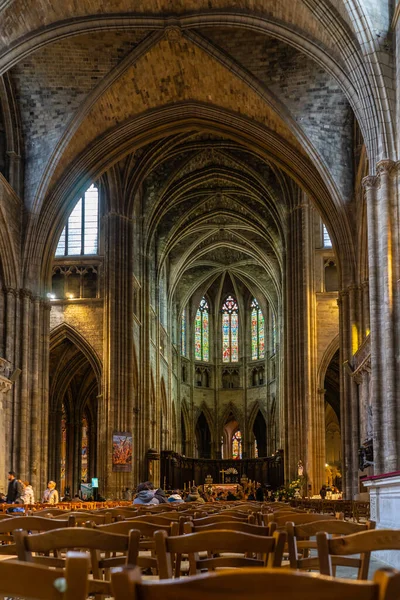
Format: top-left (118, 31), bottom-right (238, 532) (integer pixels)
top-left (133, 481), bottom-right (266, 504)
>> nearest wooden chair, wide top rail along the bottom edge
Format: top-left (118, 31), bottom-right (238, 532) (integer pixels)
top-left (112, 566), bottom-right (400, 600)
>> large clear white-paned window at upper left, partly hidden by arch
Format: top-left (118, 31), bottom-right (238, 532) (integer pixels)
top-left (56, 184), bottom-right (99, 256)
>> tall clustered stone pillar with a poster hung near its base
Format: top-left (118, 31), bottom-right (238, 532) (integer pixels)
top-left (98, 212), bottom-right (136, 497)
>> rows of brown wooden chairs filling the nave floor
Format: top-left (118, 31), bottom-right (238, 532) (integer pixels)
top-left (0, 502), bottom-right (400, 600)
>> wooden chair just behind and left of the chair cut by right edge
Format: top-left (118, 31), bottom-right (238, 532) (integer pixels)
top-left (286, 519), bottom-right (375, 579)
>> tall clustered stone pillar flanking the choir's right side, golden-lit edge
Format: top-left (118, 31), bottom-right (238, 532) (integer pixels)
top-left (284, 194), bottom-right (325, 491)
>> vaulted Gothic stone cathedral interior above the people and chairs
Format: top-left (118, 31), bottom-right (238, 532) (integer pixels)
top-left (0, 0), bottom-right (400, 498)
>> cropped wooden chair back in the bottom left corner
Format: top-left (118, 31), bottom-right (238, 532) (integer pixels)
top-left (0, 552), bottom-right (90, 600)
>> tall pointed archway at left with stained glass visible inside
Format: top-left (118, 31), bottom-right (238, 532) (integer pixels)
top-left (49, 331), bottom-right (99, 497)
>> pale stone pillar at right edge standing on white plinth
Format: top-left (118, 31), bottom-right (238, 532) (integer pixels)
top-left (363, 160), bottom-right (400, 474)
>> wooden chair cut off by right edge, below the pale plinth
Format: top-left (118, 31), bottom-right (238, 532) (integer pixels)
top-left (317, 529), bottom-right (400, 579)
